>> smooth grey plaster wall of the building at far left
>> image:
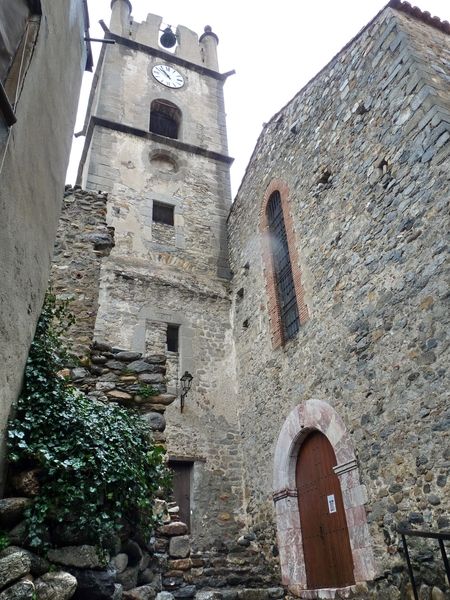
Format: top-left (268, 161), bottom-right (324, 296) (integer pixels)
top-left (0, 0), bottom-right (86, 488)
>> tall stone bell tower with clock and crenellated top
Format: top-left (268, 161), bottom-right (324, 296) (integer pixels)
top-left (79, 0), bottom-right (242, 548)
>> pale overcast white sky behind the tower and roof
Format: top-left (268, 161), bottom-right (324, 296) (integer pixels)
top-left (67, 0), bottom-right (450, 195)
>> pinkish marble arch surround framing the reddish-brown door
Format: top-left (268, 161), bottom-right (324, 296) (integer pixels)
top-left (273, 399), bottom-right (375, 596)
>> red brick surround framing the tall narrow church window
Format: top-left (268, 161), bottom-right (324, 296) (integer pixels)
top-left (260, 179), bottom-right (308, 348)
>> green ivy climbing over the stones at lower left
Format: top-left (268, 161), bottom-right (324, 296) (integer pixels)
top-left (8, 293), bottom-right (169, 550)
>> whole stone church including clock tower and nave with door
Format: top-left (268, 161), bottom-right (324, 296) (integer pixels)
top-left (53, 0), bottom-right (450, 599)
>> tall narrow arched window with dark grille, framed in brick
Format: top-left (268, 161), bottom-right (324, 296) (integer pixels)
top-left (266, 191), bottom-right (300, 341)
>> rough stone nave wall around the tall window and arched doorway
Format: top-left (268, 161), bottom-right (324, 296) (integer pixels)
top-left (229, 8), bottom-right (450, 598)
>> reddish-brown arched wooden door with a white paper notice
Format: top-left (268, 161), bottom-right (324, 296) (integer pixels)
top-left (296, 431), bottom-right (355, 589)
